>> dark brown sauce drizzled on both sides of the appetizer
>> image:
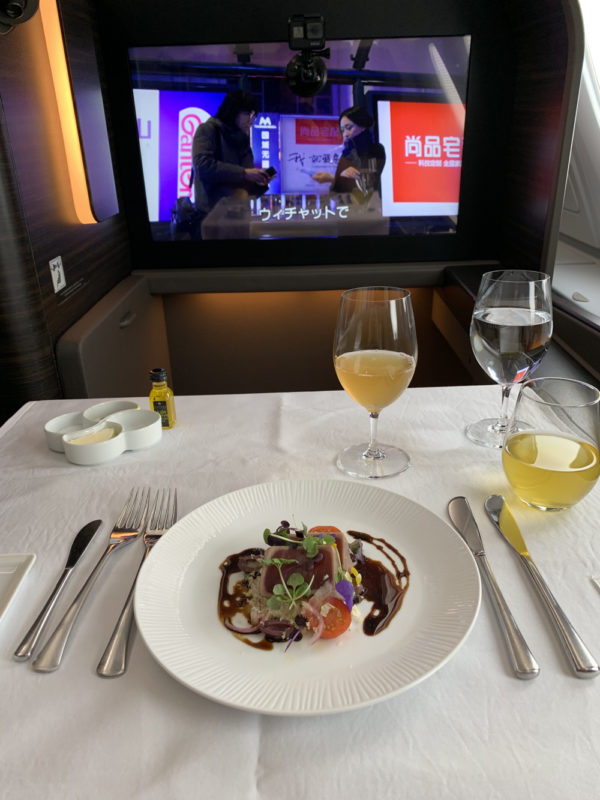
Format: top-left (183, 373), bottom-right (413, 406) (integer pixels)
top-left (218, 531), bottom-right (410, 650)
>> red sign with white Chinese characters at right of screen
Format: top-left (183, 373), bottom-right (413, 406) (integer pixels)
top-left (390, 102), bottom-right (465, 203)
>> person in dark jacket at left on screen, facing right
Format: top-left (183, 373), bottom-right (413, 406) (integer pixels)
top-left (192, 89), bottom-right (269, 216)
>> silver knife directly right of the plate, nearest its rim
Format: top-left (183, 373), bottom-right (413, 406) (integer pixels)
top-left (448, 497), bottom-right (540, 680)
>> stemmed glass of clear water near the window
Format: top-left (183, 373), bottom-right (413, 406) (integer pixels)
top-left (465, 269), bottom-right (552, 448)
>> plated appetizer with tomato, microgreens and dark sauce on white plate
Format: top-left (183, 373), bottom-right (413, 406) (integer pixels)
top-left (218, 520), bottom-right (410, 649)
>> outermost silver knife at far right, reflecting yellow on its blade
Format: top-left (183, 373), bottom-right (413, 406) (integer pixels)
top-left (485, 494), bottom-right (600, 678)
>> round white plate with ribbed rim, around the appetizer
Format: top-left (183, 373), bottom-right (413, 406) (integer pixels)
top-left (135, 480), bottom-right (481, 715)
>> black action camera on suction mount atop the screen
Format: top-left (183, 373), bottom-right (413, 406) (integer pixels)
top-left (285, 14), bottom-right (330, 97)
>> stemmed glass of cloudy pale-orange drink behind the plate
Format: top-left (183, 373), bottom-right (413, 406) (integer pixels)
top-left (333, 286), bottom-right (417, 478)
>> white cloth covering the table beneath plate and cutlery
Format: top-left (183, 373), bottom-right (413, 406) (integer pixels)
top-left (0, 386), bottom-right (600, 800)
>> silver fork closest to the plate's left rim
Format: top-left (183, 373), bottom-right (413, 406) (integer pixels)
top-left (96, 489), bottom-right (177, 678)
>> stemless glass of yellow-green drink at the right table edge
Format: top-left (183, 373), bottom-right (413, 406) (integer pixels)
top-left (502, 378), bottom-right (600, 511)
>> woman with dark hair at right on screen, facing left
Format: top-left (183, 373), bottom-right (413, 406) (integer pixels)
top-left (312, 106), bottom-right (385, 192)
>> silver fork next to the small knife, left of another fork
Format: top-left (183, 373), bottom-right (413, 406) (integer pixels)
top-left (32, 489), bottom-right (150, 672)
